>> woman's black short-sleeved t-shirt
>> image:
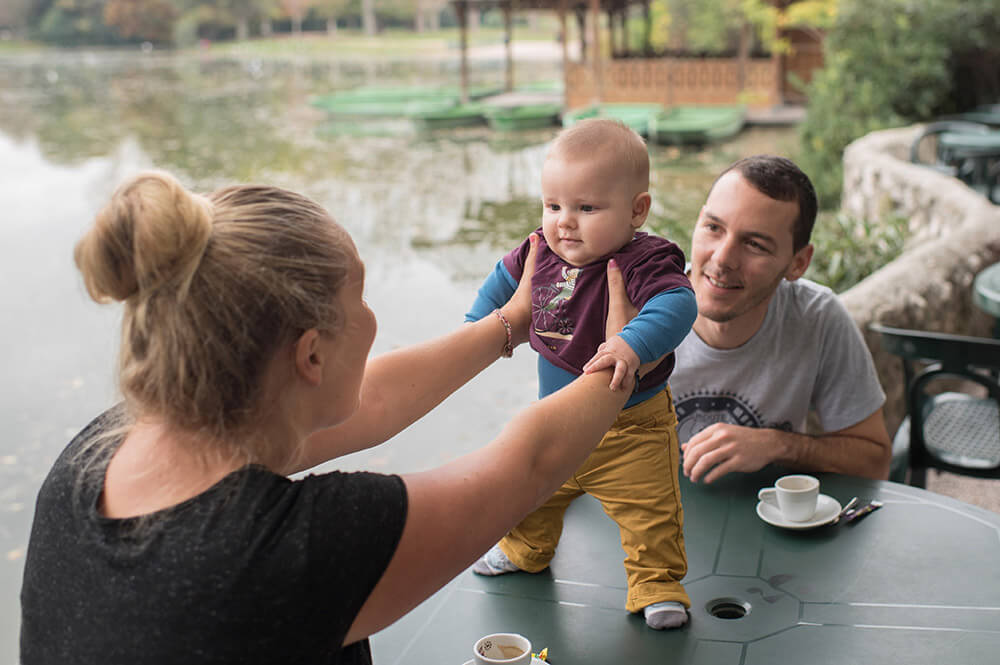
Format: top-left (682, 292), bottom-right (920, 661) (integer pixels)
top-left (21, 412), bottom-right (407, 665)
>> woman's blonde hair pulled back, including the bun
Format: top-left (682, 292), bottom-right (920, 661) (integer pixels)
top-left (74, 172), bottom-right (357, 459)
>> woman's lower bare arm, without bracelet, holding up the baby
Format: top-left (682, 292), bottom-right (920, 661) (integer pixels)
top-left (345, 258), bottom-right (634, 643)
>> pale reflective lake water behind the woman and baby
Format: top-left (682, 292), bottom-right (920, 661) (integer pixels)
top-left (0, 52), bottom-right (794, 665)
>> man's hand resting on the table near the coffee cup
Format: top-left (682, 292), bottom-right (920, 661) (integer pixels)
top-left (681, 423), bottom-right (780, 483)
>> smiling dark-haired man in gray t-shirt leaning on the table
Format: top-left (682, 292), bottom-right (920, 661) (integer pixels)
top-left (670, 155), bottom-right (892, 482)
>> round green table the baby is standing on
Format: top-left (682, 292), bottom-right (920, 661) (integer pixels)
top-left (372, 470), bottom-right (1000, 665)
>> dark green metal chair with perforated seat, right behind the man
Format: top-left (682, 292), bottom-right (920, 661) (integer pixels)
top-left (869, 323), bottom-right (1000, 487)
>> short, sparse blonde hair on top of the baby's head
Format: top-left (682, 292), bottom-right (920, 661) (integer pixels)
top-left (548, 118), bottom-right (649, 192)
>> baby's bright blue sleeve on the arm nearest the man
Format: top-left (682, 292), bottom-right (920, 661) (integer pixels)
top-left (618, 288), bottom-right (698, 363)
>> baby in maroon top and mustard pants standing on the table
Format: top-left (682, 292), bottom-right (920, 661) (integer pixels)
top-left (465, 119), bottom-right (697, 629)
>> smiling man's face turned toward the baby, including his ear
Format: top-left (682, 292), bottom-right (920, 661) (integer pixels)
top-left (691, 171), bottom-right (812, 332)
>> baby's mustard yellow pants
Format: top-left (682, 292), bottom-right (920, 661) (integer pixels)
top-left (500, 389), bottom-right (691, 612)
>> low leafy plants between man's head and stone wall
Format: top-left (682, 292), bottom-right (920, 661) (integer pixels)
top-left (806, 212), bottom-right (907, 293)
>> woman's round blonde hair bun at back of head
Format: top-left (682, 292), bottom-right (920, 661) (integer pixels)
top-left (74, 172), bottom-right (213, 302)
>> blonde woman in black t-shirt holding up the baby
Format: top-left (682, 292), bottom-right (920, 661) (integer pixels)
top-left (21, 173), bottom-right (632, 665)
